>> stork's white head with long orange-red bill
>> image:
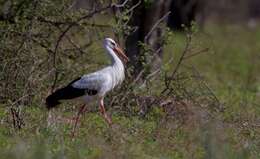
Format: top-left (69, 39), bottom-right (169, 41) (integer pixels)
top-left (104, 38), bottom-right (129, 63)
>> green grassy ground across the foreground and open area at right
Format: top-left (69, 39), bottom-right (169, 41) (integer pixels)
top-left (0, 24), bottom-right (260, 159)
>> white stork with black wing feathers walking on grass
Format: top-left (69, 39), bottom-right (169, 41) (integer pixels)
top-left (46, 38), bottom-right (129, 131)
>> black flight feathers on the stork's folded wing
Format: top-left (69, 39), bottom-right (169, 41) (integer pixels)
top-left (46, 77), bottom-right (98, 109)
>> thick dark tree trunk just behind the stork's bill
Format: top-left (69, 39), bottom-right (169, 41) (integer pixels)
top-left (126, 0), bottom-right (171, 75)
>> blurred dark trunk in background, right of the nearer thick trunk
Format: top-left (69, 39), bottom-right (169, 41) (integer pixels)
top-left (168, 0), bottom-right (200, 30)
